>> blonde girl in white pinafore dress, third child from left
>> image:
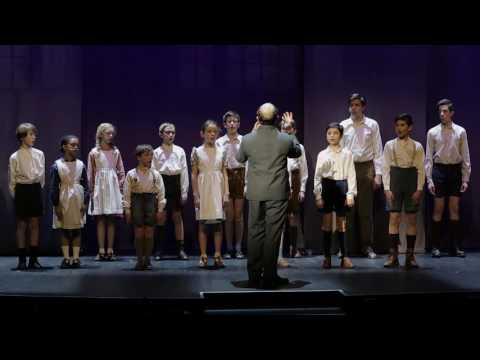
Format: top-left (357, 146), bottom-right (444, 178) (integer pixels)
top-left (87, 123), bottom-right (125, 260)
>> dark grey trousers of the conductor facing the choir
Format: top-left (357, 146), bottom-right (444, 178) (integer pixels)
top-left (247, 200), bottom-right (288, 282)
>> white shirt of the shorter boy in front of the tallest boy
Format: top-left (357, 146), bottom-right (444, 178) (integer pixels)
top-left (313, 146), bottom-right (357, 199)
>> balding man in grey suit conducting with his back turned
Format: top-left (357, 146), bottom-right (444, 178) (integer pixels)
top-left (237, 103), bottom-right (302, 289)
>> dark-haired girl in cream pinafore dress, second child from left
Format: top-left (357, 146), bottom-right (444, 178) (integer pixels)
top-left (50, 135), bottom-right (89, 269)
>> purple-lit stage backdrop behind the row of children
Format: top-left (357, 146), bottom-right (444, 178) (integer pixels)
top-left (0, 45), bottom-right (480, 254)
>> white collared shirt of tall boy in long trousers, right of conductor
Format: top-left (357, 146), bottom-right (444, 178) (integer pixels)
top-left (340, 116), bottom-right (382, 175)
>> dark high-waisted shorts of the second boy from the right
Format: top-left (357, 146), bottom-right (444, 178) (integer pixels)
top-left (387, 166), bottom-right (419, 214)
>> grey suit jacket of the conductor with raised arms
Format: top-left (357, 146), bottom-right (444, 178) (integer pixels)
top-left (237, 125), bottom-right (302, 201)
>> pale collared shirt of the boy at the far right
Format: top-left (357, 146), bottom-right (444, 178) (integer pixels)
top-left (425, 122), bottom-right (472, 184)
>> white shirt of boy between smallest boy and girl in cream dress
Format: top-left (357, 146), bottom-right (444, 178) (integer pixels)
top-left (152, 144), bottom-right (189, 200)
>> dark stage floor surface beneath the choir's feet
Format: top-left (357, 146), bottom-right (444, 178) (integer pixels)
top-left (0, 253), bottom-right (480, 300)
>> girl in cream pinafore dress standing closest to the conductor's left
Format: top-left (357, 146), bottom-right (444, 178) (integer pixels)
top-left (191, 120), bottom-right (230, 268)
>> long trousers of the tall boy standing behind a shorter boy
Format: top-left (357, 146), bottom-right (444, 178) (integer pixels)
top-left (346, 161), bottom-right (375, 253)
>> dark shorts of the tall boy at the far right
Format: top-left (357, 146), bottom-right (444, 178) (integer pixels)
top-left (432, 163), bottom-right (462, 197)
